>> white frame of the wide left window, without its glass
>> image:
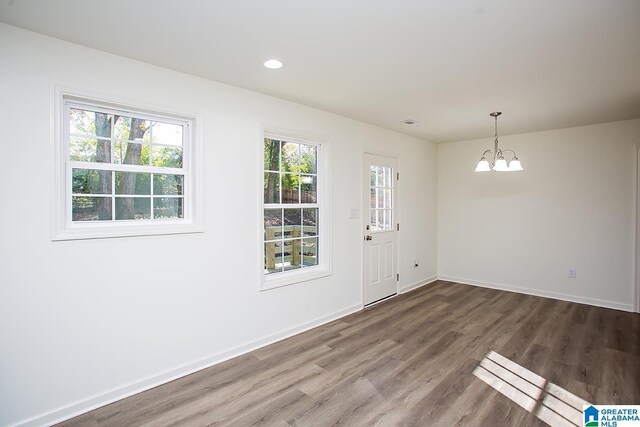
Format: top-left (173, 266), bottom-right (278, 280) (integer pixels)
top-left (51, 87), bottom-right (203, 241)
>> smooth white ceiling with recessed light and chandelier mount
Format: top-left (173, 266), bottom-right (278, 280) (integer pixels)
top-left (0, 0), bottom-right (640, 142)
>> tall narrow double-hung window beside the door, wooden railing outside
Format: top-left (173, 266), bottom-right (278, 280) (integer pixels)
top-left (263, 135), bottom-right (326, 287)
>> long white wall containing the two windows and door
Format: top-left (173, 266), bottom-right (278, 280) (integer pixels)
top-left (0, 24), bottom-right (438, 425)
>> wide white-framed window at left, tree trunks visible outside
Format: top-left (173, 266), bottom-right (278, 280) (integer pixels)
top-left (54, 92), bottom-right (199, 239)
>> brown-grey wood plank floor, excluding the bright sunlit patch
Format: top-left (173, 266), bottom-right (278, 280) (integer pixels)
top-left (61, 281), bottom-right (640, 426)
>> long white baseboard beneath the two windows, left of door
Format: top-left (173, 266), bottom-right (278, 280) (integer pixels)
top-left (9, 304), bottom-right (362, 427)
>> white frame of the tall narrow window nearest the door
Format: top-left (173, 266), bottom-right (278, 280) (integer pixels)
top-left (258, 127), bottom-right (332, 291)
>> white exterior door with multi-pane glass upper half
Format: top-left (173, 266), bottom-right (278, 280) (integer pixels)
top-left (362, 154), bottom-right (398, 305)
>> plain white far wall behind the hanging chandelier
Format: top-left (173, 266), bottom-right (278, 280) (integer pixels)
top-left (438, 116), bottom-right (640, 310)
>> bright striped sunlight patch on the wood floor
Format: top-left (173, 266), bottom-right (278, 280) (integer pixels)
top-left (473, 351), bottom-right (589, 427)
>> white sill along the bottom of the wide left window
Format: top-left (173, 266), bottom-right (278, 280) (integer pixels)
top-left (51, 221), bottom-right (204, 241)
